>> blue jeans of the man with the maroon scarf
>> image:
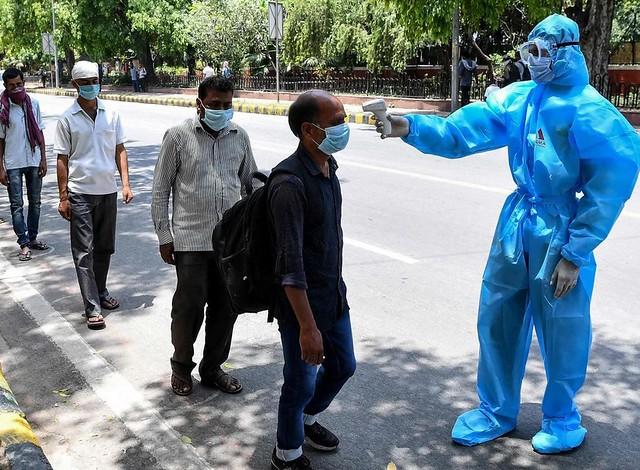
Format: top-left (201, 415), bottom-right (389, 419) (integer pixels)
top-left (7, 166), bottom-right (42, 248)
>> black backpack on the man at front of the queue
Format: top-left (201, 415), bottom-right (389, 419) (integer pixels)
top-left (213, 172), bottom-right (275, 314)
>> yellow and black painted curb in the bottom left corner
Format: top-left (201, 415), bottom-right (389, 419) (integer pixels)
top-left (0, 365), bottom-right (52, 470)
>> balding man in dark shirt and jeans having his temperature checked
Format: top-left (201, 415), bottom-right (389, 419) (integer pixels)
top-left (269, 91), bottom-right (356, 470)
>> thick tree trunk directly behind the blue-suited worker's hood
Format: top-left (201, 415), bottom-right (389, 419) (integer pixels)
top-left (566, 0), bottom-right (615, 81)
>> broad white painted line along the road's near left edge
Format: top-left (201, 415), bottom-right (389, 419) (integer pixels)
top-left (0, 255), bottom-right (212, 470)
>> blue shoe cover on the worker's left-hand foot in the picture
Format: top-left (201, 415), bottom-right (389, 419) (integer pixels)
top-left (451, 408), bottom-right (515, 447)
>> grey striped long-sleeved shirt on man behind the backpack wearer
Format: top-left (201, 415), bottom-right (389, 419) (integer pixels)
top-left (151, 118), bottom-right (257, 251)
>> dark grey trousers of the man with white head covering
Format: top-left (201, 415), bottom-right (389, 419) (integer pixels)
top-left (69, 193), bottom-right (118, 316)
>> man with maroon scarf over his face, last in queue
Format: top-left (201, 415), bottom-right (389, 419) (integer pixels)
top-left (0, 68), bottom-right (49, 261)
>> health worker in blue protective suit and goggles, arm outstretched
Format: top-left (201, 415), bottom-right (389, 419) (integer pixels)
top-left (378, 15), bottom-right (640, 453)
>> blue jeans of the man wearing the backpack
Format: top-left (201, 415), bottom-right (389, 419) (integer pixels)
top-left (278, 310), bottom-right (356, 450)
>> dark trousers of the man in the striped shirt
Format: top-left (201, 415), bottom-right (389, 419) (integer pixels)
top-left (171, 251), bottom-right (237, 381)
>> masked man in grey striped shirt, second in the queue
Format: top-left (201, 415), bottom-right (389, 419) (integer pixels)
top-left (151, 77), bottom-right (257, 395)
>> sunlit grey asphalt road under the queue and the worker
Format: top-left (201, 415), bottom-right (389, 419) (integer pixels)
top-left (0, 92), bottom-right (640, 470)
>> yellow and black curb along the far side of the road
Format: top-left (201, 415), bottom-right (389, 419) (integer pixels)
top-left (29, 88), bottom-right (376, 126)
